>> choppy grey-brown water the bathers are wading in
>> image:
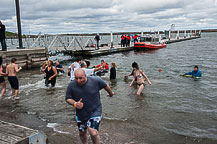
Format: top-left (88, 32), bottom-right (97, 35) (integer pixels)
top-left (3, 33), bottom-right (217, 144)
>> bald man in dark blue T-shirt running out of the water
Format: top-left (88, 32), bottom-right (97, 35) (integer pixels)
top-left (65, 68), bottom-right (114, 144)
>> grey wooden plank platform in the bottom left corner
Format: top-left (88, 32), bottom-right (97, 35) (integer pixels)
top-left (0, 121), bottom-right (48, 144)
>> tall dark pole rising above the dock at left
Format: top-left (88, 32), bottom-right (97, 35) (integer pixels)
top-left (15, 0), bottom-right (23, 49)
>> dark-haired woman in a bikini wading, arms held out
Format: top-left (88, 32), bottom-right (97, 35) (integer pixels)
top-left (130, 62), bottom-right (151, 95)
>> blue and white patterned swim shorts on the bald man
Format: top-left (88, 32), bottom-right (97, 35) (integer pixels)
top-left (75, 116), bottom-right (102, 131)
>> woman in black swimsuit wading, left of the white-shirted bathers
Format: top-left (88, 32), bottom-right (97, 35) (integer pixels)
top-left (44, 60), bottom-right (57, 87)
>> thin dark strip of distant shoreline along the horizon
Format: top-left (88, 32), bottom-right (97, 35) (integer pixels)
top-left (6, 29), bottom-right (217, 39)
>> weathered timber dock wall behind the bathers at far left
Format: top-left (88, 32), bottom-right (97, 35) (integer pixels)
top-left (0, 48), bottom-right (49, 69)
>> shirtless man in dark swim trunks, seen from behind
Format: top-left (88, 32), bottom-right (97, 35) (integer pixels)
top-left (6, 58), bottom-right (22, 99)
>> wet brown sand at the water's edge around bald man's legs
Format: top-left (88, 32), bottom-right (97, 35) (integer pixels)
top-left (0, 99), bottom-right (216, 144)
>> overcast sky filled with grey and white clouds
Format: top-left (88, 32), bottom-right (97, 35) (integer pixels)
top-left (0, 0), bottom-right (217, 34)
